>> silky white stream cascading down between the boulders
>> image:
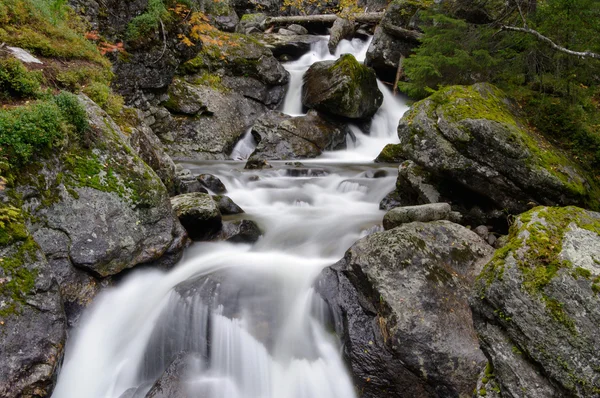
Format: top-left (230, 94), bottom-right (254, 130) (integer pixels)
top-left (53, 37), bottom-right (408, 398)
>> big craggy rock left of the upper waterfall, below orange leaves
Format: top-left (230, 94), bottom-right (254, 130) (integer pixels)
top-left (152, 33), bottom-right (289, 160)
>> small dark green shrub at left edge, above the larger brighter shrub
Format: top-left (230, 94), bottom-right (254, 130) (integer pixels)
top-left (0, 58), bottom-right (42, 98)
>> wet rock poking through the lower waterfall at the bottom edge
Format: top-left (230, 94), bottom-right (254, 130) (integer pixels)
top-left (145, 353), bottom-right (193, 398)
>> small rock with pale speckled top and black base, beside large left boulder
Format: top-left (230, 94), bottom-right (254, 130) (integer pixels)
top-left (171, 192), bottom-right (221, 240)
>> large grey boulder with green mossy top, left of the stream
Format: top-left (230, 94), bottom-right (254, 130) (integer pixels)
top-left (7, 96), bottom-right (186, 325)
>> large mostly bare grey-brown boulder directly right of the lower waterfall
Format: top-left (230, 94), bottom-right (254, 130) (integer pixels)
top-left (315, 221), bottom-right (492, 398)
